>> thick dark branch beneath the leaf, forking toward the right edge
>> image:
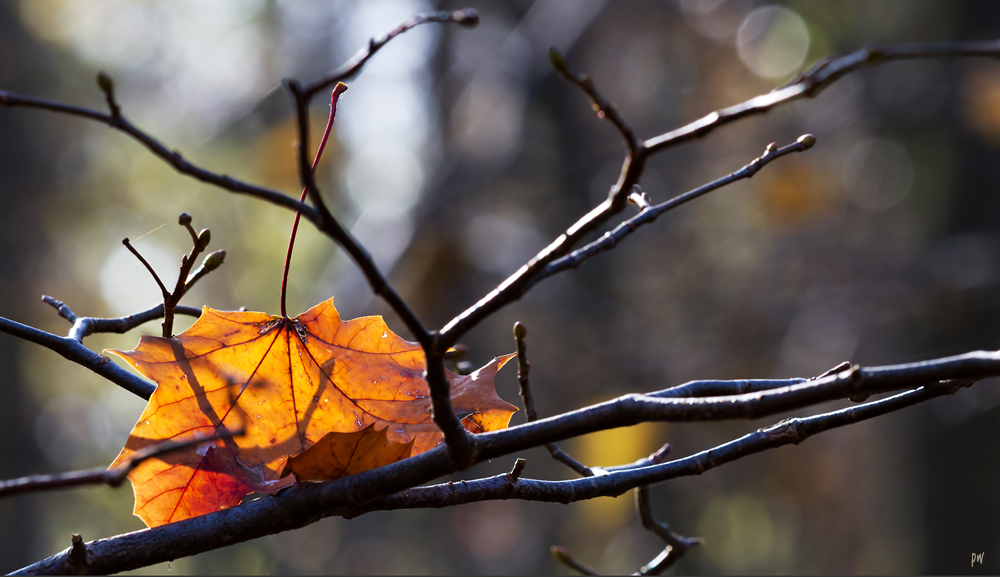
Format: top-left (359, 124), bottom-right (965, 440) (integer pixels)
top-left (9, 353), bottom-right (1000, 573)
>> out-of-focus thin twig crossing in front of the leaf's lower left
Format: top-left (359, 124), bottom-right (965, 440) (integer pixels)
top-left (0, 430), bottom-right (244, 498)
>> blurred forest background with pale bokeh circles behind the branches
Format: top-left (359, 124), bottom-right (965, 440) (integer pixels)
top-left (0, 0), bottom-right (1000, 574)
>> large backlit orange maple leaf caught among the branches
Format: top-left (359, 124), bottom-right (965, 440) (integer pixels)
top-left (109, 299), bottom-right (517, 527)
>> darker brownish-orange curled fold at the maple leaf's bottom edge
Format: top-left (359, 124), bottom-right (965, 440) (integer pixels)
top-left (282, 424), bottom-right (413, 481)
